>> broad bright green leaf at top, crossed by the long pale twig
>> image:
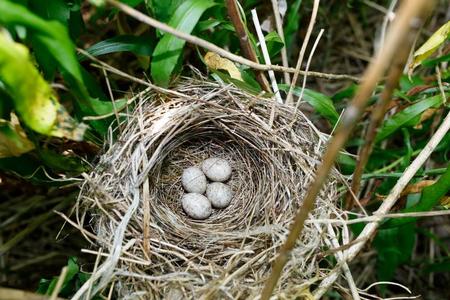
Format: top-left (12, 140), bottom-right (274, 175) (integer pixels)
top-left (151, 0), bottom-right (215, 87)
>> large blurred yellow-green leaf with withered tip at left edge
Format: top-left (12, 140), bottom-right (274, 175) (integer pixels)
top-left (0, 32), bottom-right (86, 140)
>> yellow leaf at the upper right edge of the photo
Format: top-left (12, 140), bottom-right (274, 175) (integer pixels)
top-left (408, 21), bottom-right (450, 75)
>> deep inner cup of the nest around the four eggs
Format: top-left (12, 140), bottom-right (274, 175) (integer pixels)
top-left (144, 104), bottom-right (305, 244)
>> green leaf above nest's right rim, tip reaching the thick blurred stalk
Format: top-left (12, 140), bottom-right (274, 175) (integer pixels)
top-left (278, 84), bottom-right (339, 126)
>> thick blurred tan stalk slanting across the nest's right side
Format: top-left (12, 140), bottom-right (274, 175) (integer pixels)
top-left (261, 0), bottom-right (433, 300)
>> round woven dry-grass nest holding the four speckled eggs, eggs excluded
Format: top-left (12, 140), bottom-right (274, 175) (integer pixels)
top-left (77, 79), bottom-right (337, 299)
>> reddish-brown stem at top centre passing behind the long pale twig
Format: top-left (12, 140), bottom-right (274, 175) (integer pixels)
top-left (225, 0), bottom-right (270, 92)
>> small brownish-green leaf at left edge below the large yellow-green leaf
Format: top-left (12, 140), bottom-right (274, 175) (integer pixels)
top-left (0, 114), bottom-right (34, 158)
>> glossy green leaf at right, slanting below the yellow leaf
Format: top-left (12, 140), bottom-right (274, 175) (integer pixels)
top-left (375, 95), bottom-right (442, 142)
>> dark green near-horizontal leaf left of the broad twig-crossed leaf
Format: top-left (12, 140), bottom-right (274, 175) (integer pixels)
top-left (78, 35), bottom-right (153, 61)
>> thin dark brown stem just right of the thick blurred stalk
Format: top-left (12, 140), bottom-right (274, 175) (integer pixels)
top-left (345, 10), bottom-right (418, 209)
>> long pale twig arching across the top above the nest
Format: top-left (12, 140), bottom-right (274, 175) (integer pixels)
top-left (106, 0), bottom-right (360, 81)
